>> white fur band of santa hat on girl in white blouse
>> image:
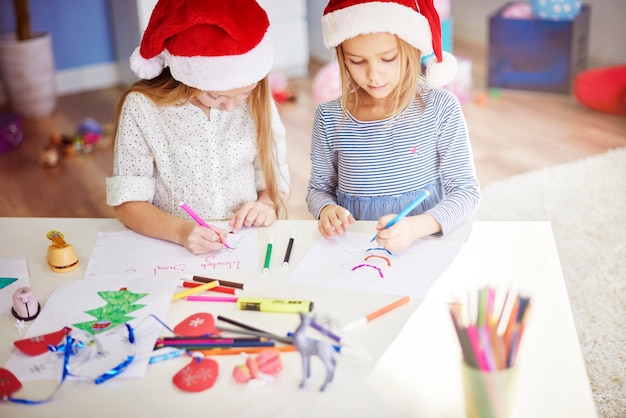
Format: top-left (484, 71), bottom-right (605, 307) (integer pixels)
top-left (164, 30), bottom-right (274, 91)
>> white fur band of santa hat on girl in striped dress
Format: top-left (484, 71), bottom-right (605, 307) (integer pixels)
top-left (322, 2), bottom-right (433, 55)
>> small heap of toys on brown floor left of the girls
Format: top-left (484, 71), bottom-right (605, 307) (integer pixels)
top-left (40, 118), bottom-right (111, 167)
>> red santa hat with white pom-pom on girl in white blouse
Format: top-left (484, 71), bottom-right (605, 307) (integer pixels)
top-left (130, 0), bottom-right (274, 91)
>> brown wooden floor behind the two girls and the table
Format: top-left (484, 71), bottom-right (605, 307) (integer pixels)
top-left (0, 41), bottom-right (626, 219)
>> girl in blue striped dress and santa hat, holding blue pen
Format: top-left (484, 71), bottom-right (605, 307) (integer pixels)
top-left (307, 0), bottom-right (480, 252)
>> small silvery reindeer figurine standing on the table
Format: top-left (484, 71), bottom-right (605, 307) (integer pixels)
top-left (293, 312), bottom-right (337, 392)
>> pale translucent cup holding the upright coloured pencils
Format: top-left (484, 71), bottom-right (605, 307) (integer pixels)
top-left (461, 361), bottom-right (517, 418)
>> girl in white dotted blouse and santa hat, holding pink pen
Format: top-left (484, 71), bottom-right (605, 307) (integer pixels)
top-left (106, 0), bottom-right (289, 254)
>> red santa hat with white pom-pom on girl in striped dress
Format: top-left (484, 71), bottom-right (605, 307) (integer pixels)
top-left (322, 0), bottom-right (457, 87)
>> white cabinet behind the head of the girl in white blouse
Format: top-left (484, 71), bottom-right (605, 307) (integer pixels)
top-left (111, 0), bottom-right (309, 85)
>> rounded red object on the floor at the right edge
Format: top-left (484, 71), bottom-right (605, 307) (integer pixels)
top-left (572, 65), bottom-right (626, 115)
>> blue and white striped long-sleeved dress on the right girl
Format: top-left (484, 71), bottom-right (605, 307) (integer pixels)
top-left (306, 89), bottom-right (480, 234)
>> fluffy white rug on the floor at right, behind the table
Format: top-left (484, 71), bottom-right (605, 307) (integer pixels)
top-left (476, 148), bottom-right (626, 418)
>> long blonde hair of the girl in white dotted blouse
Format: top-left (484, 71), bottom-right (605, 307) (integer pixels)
top-left (113, 68), bottom-right (287, 219)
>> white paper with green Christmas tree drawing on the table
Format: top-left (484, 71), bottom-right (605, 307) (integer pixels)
top-left (5, 274), bottom-right (179, 381)
